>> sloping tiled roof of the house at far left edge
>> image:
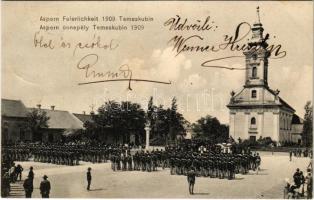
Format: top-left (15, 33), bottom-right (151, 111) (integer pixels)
top-left (1, 99), bottom-right (27, 117)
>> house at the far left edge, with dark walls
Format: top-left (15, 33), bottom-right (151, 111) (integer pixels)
top-left (1, 99), bottom-right (32, 144)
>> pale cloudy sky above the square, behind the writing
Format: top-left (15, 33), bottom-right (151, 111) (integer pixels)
top-left (1, 1), bottom-right (313, 123)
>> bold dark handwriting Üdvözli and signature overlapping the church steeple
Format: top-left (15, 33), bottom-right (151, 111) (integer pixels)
top-left (164, 15), bottom-right (287, 70)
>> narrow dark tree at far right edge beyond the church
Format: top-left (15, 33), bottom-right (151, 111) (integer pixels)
top-left (302, 101), bottom-right (313, 147)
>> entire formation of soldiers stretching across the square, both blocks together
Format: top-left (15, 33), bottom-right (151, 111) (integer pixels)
top-left (2, 143), bottom-right (261, 182)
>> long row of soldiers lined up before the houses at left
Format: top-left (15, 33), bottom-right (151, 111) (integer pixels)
top-left (2, 144), bottom-right (129, 165)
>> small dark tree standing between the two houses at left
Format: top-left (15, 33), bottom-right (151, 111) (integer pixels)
top-left (26, 109), bottom-right (49, 141)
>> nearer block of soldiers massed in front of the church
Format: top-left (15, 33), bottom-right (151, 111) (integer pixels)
top-left (106, 141), bottom-right (261, 179)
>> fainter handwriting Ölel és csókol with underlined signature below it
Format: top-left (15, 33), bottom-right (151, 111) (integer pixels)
top-left (34, 32), bottom-right (171, 90)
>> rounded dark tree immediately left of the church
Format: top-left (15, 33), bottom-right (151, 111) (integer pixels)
top-left (192, 115), bottom-right (229, 144)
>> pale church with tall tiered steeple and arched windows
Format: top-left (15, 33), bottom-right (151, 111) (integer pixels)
top-left (227, 8), bottom-right (302, 144)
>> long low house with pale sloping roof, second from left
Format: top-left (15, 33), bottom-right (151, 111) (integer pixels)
top-left (29, 106), bottom-right (84, 143)
